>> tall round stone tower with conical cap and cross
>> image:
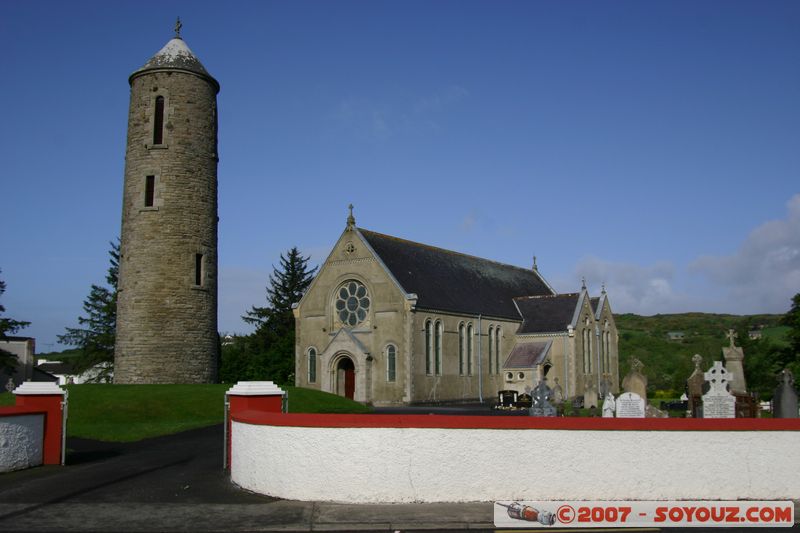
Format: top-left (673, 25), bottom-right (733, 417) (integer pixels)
top-left (114, 21), bottom-right (219, 383)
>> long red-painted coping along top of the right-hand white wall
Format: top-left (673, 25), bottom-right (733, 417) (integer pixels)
top-left (231, 410), bottom-right (800, 431)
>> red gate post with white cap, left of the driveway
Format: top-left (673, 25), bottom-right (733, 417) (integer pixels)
top-left (12, 381), bottom-right (68, 465)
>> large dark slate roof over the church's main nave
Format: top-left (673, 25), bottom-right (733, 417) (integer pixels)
top-left (357, 228), bottom-right (553, 320)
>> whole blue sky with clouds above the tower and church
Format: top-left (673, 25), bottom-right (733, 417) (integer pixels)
top-left (0, 0), bottom-right (800, 351)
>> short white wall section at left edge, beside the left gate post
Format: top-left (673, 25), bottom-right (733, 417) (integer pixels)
top-left (0, 414), bottom-right (44, 472)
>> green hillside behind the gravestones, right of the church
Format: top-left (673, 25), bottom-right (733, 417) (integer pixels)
top-left (614, 313), bottom-right (788, 397)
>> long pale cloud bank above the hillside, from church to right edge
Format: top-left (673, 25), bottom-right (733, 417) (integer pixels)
top-left (553, 194), bottom-right (800, 315)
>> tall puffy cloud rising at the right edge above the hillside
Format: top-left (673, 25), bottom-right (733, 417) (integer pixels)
top-left (689, 194), bottom-right (800, 314)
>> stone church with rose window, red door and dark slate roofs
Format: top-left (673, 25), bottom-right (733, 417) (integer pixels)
top-left (294, 208), bottom-right (619, 405)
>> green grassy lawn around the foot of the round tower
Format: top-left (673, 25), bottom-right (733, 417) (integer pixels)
top-left (0, 384), bottom-right (371, 442)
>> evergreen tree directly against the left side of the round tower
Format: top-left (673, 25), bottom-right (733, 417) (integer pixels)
top-left (58, 240), bottom-right (119, 381)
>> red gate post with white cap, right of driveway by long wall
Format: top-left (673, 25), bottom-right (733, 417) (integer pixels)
top-left (223, 381), bottom-right (288, 469)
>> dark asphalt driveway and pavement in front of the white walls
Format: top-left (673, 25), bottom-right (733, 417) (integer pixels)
top-left (0, 425), bottom-right (798, 533)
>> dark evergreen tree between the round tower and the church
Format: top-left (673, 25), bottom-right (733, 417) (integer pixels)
top-left (230, 248), bottom-right (317, 383)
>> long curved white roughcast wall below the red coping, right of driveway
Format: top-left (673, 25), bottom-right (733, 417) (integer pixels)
top-left (231, 421), bottom-right (800, 503)
